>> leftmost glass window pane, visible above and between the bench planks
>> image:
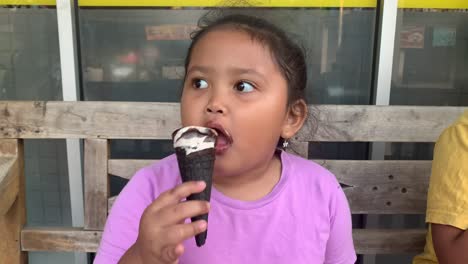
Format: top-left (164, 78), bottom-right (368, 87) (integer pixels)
top-left (0, 0), bottom-right (74, 263)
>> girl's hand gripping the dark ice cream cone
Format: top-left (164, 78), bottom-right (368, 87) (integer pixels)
top-left (119, 182), bottom-right (210, 264)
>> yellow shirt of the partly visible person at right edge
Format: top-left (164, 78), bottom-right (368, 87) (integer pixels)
top-left (413, 110), bottom-right (468, 264)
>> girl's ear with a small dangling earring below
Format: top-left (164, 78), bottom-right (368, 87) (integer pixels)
top-left (281, 99), bottom-right (308, 139)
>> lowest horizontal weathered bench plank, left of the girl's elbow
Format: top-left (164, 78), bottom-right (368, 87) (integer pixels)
top-left (21, 228), bottom-right (102, 252)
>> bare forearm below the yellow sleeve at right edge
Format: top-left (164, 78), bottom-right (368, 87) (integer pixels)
top-left (431, 224), bottom-right (468, 264)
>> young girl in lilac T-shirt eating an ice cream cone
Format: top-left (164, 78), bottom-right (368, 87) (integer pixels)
top-left (95, 15), bottom-right (356, 264)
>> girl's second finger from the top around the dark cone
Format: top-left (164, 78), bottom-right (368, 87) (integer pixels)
top-left (157, 201), bottom-right (210, 227)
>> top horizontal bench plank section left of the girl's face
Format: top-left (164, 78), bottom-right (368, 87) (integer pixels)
top-left (0, 101), bottom-right (180, 139)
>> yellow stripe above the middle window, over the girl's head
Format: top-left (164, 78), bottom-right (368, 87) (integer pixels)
top-left (78, 0), bottom-right (377, 7)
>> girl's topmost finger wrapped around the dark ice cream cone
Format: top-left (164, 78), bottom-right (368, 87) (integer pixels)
top-left (148, 181), bottom-right (206, 212)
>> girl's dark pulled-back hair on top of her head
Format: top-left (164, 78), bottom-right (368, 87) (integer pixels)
top-left (184, 14), bottom-right (307, 105)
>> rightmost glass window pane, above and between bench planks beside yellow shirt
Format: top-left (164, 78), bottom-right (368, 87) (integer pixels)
top-left (375, 4), bottom-right (468, 263)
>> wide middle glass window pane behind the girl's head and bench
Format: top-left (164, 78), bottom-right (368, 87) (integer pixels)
top-left (79, 4), bottom-right (376, 264)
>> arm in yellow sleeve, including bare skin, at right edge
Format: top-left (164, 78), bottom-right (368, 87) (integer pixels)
top-left (427, 117), bottom-right (468, 264)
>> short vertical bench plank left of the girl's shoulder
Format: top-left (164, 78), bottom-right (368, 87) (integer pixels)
top-left (84, 139), bottom-right (109, 230)
